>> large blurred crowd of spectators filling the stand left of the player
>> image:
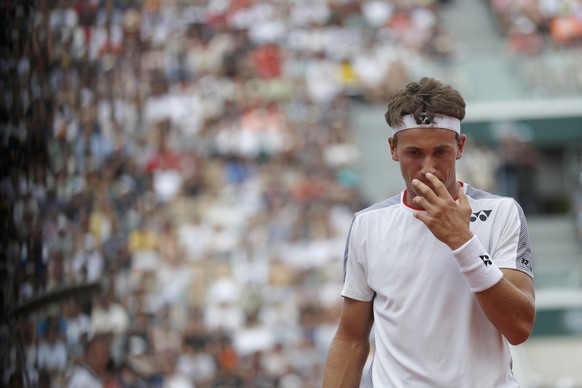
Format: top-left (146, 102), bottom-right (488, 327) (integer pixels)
top-left (0, 0), bottom-right (454, 387)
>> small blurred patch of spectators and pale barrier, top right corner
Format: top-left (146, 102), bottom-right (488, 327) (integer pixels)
top-left (487, 0), bottom-right (582, 98)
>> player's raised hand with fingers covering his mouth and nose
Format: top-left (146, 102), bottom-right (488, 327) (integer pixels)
top-left (412, 173), bottom-right (473, 250)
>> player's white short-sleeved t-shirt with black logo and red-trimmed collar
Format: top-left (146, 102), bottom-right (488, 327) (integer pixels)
top-left (342, 184), bottom-right (533, 388)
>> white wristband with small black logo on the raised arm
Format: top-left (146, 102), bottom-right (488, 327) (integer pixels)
top-left (453, 236), bottom-right (503, 292)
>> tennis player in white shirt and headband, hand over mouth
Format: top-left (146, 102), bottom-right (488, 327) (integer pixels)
top-left (323, 78), bottom-right (535, 388)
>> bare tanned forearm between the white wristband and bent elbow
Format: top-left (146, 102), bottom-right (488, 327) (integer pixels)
top-left (475, 276), bottom-right (535, 345)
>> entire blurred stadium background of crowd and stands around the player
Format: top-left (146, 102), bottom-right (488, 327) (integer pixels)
top-left (0, 0), bottom-right (582, 388)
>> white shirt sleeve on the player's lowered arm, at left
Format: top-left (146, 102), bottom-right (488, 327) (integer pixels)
top-left (341, 217), bottom-right (374, 302)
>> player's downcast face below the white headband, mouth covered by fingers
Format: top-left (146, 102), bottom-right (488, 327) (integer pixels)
top-left (388, 128), bottom-right (466, 204)
